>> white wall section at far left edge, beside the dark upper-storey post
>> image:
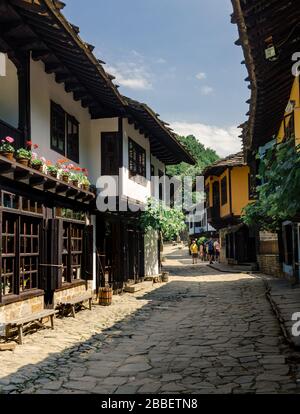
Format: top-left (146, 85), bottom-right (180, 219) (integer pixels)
top-left (0, 55), bottom-right (19, 128)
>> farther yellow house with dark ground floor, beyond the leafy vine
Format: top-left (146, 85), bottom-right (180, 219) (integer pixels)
top-left (204, 152), bottom-right (256, 266)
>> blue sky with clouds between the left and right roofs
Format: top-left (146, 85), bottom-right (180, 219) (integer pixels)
top-left (63, 0), bottom-right (250, 156)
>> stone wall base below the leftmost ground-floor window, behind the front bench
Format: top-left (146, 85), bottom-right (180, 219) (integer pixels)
top-left (0, 295), bottom-right (44, 335)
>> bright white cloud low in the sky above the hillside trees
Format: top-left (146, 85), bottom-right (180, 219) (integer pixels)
top-left (171, 122), bottom-right (242, 157)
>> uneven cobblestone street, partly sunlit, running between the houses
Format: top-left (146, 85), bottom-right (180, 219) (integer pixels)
top-left (0, 248), bottom-right (298, 394)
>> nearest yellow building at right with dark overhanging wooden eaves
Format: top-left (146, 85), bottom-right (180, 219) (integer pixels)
top-left (232, 0), bottom-right (300, 283)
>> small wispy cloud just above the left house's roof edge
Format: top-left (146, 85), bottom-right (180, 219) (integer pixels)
top-left (105, 62), bottom-right (152, 90)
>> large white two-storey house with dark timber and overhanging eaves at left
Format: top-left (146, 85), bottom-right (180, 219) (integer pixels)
top-left (0, 0), bottom-right (193, 326)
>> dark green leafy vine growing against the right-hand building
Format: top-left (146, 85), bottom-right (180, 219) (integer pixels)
top-left (243, 140), bottom-right (300, 231)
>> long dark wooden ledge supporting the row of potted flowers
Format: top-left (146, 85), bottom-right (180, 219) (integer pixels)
top-left (0, 155), bottom-right (96, 203)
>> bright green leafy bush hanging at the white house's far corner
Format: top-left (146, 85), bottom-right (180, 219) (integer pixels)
top-left (140, 199), bottom-right (186, 240)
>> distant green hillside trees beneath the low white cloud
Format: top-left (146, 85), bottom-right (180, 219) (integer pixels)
top-left (167, 135), bottom-right (219, 177)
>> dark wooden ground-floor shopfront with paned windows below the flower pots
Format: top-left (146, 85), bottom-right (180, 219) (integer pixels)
top-left (0, 156), bottom-right (95, 307)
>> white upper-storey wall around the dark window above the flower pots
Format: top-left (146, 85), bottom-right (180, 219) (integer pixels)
top-left (31, 57), bottom-right (118, 184)
